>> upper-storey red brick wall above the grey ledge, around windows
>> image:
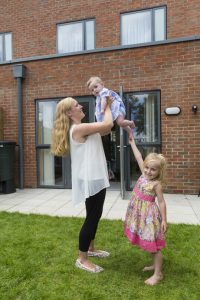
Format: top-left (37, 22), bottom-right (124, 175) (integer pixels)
top-left (0, 0), bottom-right (200, 58)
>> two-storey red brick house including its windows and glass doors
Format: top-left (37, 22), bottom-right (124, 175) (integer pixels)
top-left (0, 0), bottom-right (200, 194)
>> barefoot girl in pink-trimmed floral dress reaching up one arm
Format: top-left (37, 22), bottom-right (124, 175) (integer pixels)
top-left (124, 138), bottom-right (167, 285)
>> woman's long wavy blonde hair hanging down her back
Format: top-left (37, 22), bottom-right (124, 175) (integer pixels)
top-left (51, 97), bottom-right (74, 156)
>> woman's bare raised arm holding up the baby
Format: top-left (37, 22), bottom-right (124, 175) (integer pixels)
top-left (73, 105), bottom-right (113, 142)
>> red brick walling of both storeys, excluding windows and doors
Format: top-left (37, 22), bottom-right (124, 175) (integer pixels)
top-left (0, 0), bottom-right (200, 194)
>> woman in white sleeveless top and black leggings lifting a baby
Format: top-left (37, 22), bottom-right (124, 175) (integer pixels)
top-left (51, 98), bottom-right (113, 273)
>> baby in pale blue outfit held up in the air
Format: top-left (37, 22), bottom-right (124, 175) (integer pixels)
top-left (87, 76), bottom-right (135, 139)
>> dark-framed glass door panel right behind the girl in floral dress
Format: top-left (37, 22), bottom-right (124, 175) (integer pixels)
top-left (124, 91), bottom-right (161, 190)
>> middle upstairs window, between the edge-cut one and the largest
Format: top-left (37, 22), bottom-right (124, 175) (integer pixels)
top-left (57, 20), bottom-right (95, 53)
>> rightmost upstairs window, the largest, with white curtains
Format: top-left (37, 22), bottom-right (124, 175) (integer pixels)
top-left (121, 7), bottom-right (166, 45)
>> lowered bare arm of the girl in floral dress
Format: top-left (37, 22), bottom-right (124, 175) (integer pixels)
top-left (155, 183), bottom-right (167, 233)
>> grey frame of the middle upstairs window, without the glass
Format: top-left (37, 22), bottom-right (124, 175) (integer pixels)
top-left (56, 18), bottom-right (96, 55)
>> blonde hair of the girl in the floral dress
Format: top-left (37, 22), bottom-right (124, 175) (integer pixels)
top-left (144, 153), bottom-right (167, 183)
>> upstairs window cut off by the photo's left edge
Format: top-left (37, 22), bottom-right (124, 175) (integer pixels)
top-left (0, 33), bottom-right (12, 62)
